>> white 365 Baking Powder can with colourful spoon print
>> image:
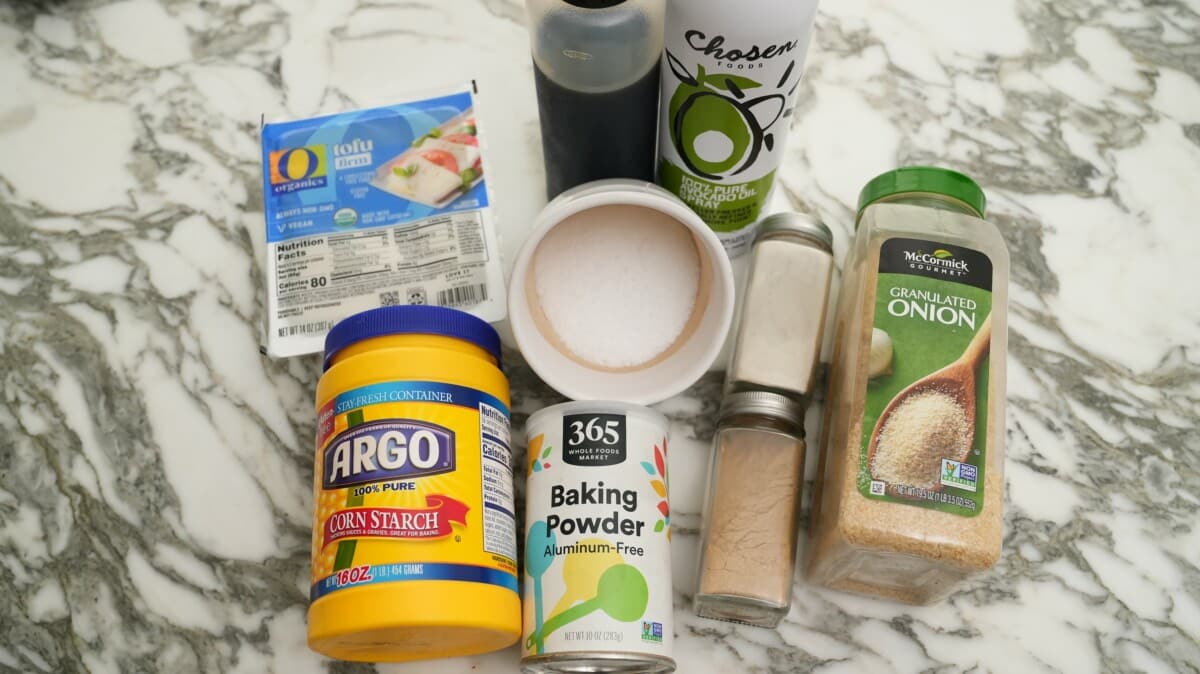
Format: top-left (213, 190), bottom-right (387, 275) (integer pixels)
top-left (521, 402), bottom-right (674, 673)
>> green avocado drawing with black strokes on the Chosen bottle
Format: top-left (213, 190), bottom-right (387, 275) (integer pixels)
top-left (666, 52), bottom-right (796, 180)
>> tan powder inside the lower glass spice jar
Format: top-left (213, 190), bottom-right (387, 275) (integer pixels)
top-left (700, 428), bottom-right (804, 597)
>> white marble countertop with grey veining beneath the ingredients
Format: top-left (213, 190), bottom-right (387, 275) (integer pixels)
top-left (0, 0), bottom-right (1200, 674)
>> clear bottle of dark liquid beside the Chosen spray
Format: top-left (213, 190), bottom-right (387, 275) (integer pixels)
top-left (527, 0), bottom-right (666, 199)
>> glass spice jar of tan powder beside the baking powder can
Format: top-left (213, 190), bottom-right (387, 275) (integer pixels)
top-left (692, 391), bottom-right (804, 627)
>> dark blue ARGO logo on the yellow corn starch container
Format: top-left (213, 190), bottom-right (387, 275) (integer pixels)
top-left (323, 419), bottom-right (455, 489)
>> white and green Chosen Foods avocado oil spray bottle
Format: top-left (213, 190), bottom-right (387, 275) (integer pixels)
top-left (658, 0), bottom-right (817, 258)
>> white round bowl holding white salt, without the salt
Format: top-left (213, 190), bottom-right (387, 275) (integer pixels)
top-left (509, 179), bottom-right (734, 404)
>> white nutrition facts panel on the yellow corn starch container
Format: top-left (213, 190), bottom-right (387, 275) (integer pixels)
top-left (479, 403), bottom-right (517, 560)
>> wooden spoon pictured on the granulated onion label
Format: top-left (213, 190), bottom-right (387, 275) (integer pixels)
top-left (866, 313), bottom-right (991, 491)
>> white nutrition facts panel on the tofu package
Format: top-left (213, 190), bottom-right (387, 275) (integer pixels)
top-left (269, 211), bottom-right (494, 352)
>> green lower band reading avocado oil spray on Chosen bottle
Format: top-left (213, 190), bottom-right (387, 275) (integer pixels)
top-left (659, 160), bottom-right (775, 233)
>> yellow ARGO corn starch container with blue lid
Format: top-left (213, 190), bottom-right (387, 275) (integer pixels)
top-left (308, 306), bottom-right (521, 662)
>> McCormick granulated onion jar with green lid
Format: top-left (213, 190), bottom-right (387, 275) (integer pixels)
top-left (808, 167), bottom-right (1008, 603)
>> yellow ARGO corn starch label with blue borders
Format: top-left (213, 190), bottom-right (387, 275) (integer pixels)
top-left (310, 381), bottom-right (517, 601)
